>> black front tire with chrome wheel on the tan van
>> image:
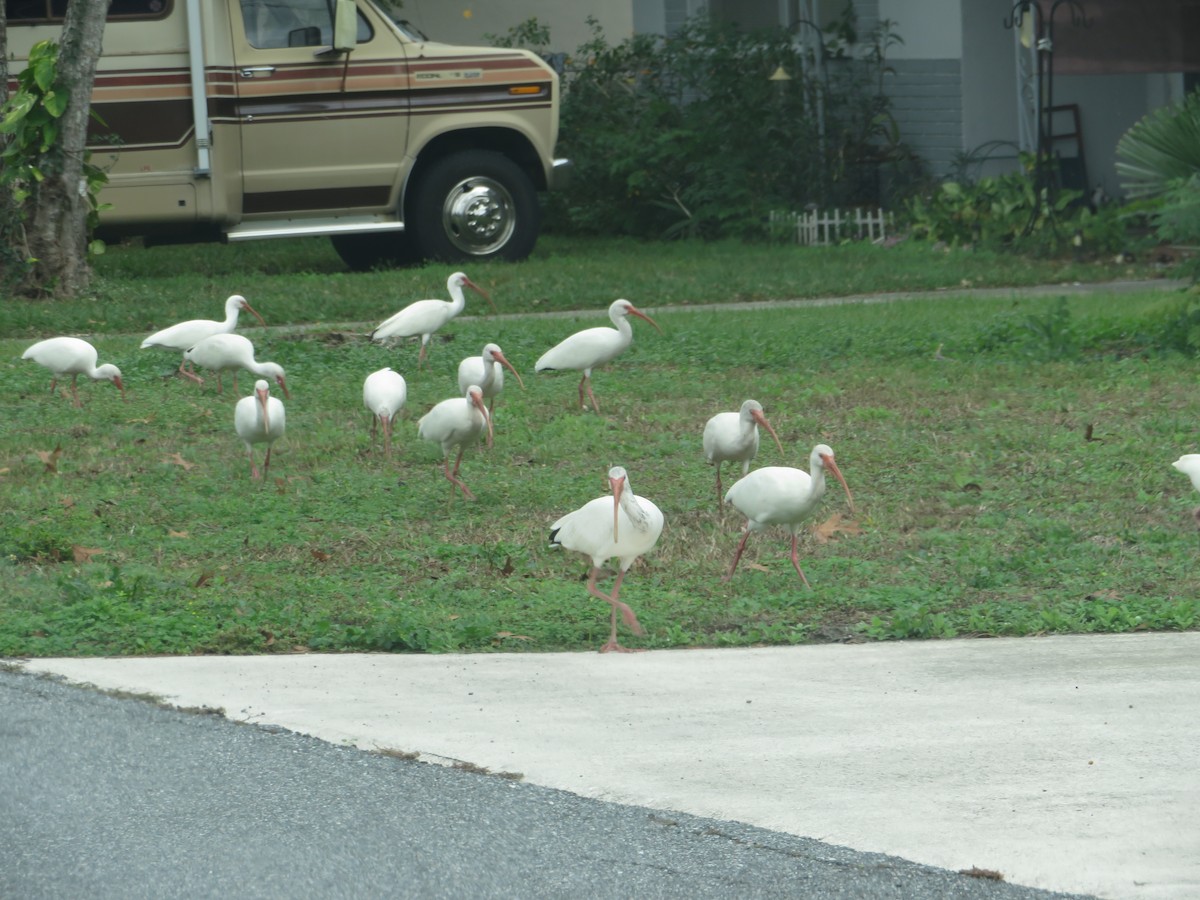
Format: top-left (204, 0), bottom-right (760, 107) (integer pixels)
top-left (406, 150), bottom-right (541, 263)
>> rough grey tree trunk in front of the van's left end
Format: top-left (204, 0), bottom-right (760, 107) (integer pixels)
top-left (25, 0), bottom-right (108, 296)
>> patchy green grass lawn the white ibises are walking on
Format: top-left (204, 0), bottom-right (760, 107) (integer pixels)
top-left (0, 239), bottom-right (1200, 656)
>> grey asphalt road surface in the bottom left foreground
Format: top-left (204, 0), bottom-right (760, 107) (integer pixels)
top-left (0, 671), bottom-right (1094, 900)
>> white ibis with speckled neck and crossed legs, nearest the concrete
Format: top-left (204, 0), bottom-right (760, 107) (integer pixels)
top-left (550, 466), bottom-right (662, 653)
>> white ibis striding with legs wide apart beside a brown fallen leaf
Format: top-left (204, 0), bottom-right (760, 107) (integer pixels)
top-left (725, 444), bottom-right (854, 588)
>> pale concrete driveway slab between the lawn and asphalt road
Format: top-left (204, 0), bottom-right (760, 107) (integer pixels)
top-left (18, 632), bottom-right (1200, 900)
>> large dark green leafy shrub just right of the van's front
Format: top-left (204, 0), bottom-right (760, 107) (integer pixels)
top-left (501, 17), bottom-right (912, 238)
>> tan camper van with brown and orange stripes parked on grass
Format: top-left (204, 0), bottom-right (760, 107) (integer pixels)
top-left (5, 0), bottom-right (570, 269)
